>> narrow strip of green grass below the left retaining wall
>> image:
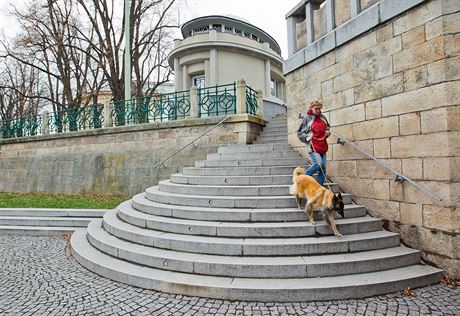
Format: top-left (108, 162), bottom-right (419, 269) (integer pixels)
top-left (0, 192), bottom-right (130, 209)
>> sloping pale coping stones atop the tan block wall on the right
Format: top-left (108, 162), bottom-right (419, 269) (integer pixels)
top-left (283, 0), bottom-right (426, 75)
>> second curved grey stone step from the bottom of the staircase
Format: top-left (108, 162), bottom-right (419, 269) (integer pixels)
top-left (87, 220), bottom-right (420, 278)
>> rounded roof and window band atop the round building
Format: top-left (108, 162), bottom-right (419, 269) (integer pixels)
top-left (181, 14), bottom-right (281, 55)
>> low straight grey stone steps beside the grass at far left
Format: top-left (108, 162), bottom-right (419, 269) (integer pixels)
top-left (0, 208), bottom-right (107, 236)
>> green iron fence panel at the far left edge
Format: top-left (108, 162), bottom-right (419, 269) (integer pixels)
top-left (0, 115), bottom-right (42, 138)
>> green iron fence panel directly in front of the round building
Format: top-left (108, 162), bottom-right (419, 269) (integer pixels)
top-left (198, 83), bottom-right (236, 117)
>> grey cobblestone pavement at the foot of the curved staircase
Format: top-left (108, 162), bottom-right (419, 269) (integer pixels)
top-left (0, 236), bottom-right (460, 316)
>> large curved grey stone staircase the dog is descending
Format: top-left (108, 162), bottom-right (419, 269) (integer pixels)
top-left (71, 115), bottom-right (442, 302)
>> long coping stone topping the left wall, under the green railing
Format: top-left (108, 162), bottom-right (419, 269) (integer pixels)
top-left (0, 114), bottom-right (267, 148)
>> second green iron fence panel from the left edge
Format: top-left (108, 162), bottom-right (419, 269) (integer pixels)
top-left (48, 104), bottom-right (104, 134)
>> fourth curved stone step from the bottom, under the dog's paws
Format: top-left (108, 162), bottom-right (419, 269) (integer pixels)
top-left (117, 201), bottom-right (382, 238)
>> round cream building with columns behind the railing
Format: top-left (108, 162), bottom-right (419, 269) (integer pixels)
top-left (169, 15), bottom-right (285, 103)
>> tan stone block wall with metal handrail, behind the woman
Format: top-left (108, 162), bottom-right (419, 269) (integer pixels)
top-left (286, 0), bottom-right (460, 278)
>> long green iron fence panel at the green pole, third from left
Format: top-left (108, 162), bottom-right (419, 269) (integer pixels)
top-left (111, 91), bottom-right (190, 126)
